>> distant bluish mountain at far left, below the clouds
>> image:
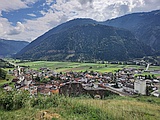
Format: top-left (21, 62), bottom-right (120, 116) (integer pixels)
top-left (0, 39), bottom-right (29, 57)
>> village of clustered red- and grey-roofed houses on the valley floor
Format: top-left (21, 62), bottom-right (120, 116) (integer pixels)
top-left (3, 66), bottom-right (160, 98)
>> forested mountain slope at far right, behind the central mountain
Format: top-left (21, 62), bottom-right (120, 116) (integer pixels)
top-left (102, 10), bottom-right (160, 51)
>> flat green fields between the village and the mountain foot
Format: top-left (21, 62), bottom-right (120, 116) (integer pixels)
top-left (15, 61), bottom-right (160, 76)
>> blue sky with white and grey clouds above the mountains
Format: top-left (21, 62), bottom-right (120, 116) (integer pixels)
top-left (0, 0), bottom-right (160, 42)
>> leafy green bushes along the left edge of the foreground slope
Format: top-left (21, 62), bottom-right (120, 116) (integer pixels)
top-left (0, 91), bottom-right (67, 110)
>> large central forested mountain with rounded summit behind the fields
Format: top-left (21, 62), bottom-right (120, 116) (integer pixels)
top-left (16, 22), bottom-right (152, 61)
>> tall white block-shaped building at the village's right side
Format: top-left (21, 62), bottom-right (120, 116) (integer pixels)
top-left (134, 79), bottom-right (146, 95)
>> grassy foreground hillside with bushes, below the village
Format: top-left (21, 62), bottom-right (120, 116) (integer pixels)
top-left (0, 92), bottom-right (160, 120)
